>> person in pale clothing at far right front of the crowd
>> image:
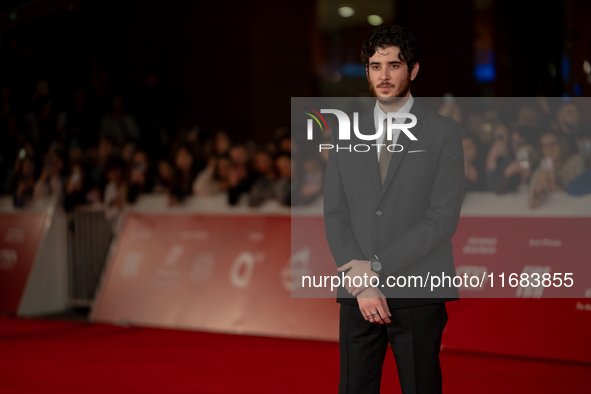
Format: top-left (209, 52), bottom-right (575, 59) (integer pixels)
top-left (528, 131), bottom-right (585, 208)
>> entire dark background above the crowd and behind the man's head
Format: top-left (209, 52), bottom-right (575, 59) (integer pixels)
top-left (0, 0), bottom-right (591, 140)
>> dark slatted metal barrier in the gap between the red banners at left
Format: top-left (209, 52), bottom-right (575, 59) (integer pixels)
top-left (68, 206), bottom-right (113, 306)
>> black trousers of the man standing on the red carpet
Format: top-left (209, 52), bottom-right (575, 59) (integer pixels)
top-left (339, 303), bottom-right (448, 394)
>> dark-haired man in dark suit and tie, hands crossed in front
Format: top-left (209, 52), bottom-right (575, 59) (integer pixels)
top-left (324, 26), bottom-right (464, 394)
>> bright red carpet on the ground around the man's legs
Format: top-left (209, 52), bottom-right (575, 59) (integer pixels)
top-left (0, 317), bottom-right (591, 394)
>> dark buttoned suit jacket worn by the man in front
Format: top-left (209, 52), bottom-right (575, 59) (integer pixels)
top-left (324, 98), bottom-right (464, 309)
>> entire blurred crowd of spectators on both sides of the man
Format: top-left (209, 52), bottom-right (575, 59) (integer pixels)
top-left (0, 38), bottom-right (591, 216)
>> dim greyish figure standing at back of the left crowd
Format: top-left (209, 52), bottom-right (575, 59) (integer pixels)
top-left (99, 96), bottom-right (140, 146)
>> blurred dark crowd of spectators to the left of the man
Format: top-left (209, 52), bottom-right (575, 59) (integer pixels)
top-left (0, 34), bottom-right (322, 216)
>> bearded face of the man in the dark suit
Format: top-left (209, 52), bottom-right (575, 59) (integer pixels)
top-left (366, 46), bottom-right (419, 104)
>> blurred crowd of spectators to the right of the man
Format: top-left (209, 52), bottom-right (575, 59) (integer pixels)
top-left (439, 97), bottom-right (591, 208)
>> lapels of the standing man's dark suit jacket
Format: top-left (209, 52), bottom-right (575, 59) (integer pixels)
top-left (359, 97), bottom-right (425, 203)
